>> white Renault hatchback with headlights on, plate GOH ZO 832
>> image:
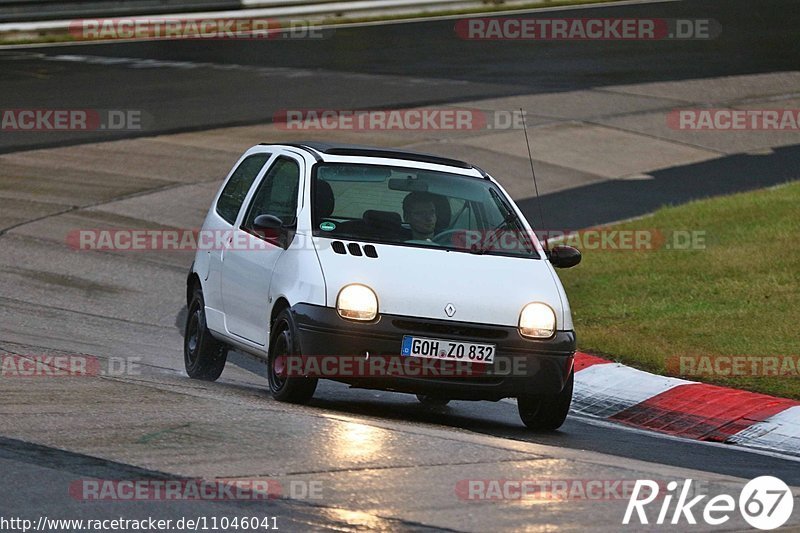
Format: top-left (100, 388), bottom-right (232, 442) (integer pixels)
top-left (184, 142), bottom-right (580, 429)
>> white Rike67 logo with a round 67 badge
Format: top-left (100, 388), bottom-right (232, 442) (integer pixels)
top-left (622, 476), bottom-right (794, 530)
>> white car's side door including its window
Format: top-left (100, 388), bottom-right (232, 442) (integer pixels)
top-left (221, 154), bottom-right (304, 347)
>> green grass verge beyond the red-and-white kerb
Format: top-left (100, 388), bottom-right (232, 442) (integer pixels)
top-left (559, 182), bottom-right (800, 399)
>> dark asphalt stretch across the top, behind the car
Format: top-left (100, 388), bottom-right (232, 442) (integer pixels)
top-left (0, 0), bottom-right (800, 152)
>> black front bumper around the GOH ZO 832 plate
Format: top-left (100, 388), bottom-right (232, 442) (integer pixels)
top-left (291, 304), bottom-right (576, 400)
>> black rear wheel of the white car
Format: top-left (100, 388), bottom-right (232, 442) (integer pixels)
top-left (183, 287), bottom-right (228, 381)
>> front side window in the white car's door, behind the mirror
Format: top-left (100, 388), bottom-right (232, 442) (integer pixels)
top-left (242, 157), bottom-right (300, 229)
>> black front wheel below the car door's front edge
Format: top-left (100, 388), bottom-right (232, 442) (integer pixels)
top-left (267, 309), bottom-right (317, 403)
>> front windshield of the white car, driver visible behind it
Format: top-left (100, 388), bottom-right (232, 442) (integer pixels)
top-left (313, 163), bottom-right (539, 258)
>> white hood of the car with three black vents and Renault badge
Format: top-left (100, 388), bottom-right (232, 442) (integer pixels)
top-left (313, 238), bottom-right (571, 329)
